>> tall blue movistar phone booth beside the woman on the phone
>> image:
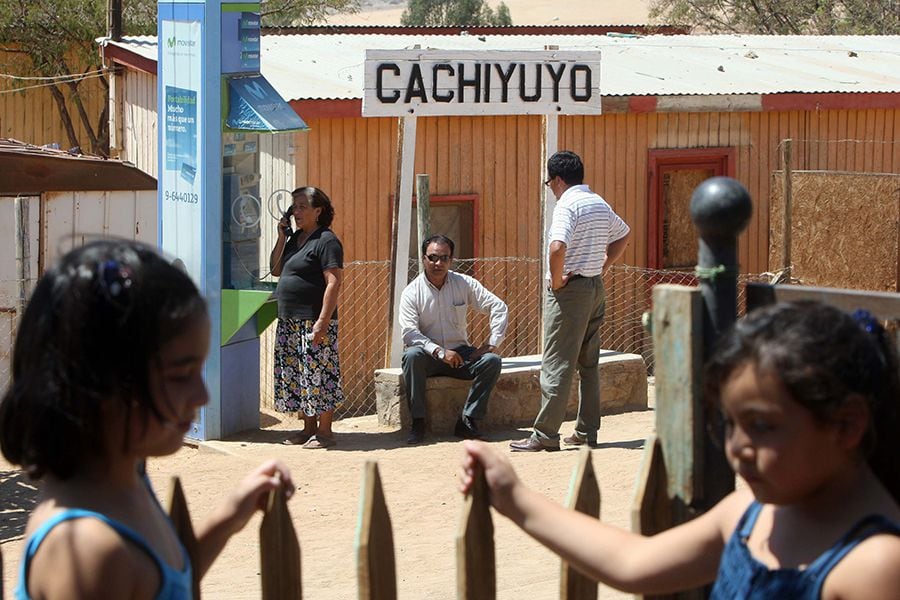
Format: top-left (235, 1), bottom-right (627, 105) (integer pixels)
top-left (157, 0), bottom-right (307, 440)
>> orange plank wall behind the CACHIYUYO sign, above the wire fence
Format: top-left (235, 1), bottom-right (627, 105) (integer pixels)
top-left (295, 109), bottom-right (900, 273)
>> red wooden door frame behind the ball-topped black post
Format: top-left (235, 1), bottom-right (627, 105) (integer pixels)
top-left (647, 146), bottom-right (737, 269)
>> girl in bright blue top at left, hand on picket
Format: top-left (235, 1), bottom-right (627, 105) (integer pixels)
top-left (0, 241), bottom-right (293, 600)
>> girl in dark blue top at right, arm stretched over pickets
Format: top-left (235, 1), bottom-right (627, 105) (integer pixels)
top-left (461, 302), bottom-right (900, 599)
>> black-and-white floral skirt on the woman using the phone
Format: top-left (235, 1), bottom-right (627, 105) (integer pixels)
top-left (275, 319), bottom-right (344, 417)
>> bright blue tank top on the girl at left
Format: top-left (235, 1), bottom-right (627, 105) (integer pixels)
top-left (15, 508), bottom-right (192, 600)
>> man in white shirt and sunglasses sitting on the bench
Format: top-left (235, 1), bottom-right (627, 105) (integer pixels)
top-left (399, 235), bottom-right (508, 444)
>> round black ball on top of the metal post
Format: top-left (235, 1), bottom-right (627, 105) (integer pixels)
top-left (691, 177), bottom-right (753, 237)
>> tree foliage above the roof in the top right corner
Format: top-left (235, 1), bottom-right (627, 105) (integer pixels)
top-left (650, 0), bottom-right (900, 35)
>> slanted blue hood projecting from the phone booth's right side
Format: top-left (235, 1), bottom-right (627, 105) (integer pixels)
top-left (225, 75), bottom-right (309, 132)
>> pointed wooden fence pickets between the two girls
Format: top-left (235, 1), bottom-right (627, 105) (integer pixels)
top-left (161, 448), bottom-right (600, 600)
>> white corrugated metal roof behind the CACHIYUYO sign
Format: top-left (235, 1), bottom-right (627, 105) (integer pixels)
top-left (102, 34), bottom-right (900, 100)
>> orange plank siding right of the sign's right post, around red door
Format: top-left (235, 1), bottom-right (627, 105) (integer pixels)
top-left (559, 109), bottom-right (900, 273)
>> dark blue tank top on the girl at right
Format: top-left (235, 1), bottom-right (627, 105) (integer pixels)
top-left (710, 501), bottom-right (900, 600)
